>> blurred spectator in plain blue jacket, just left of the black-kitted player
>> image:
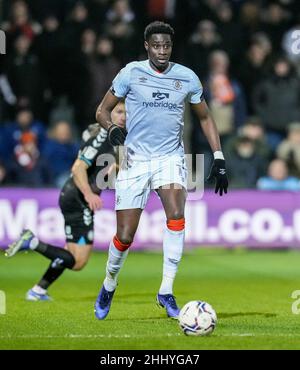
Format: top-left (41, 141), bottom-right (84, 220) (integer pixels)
top-left (42, 121), bottom-right (79, 188)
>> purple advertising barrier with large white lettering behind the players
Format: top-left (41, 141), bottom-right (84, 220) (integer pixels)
top-left (0, 188), bottom-right (300, 249)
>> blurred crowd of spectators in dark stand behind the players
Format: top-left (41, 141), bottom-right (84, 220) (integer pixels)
top-left (0, 0), bottom-right (300, 191)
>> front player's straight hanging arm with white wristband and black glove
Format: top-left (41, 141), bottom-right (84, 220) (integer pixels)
top-left (192, 100), bottom-right (228, 196)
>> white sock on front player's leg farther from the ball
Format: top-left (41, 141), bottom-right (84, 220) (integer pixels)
top-left (104, 241), bottom-right (129, 292)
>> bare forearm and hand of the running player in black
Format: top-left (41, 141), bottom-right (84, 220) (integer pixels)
top-left (72, 159), bottom-right (102, 211)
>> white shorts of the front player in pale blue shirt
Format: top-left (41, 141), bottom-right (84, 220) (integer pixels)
top-left (115, 154), bottom-right (187, 210)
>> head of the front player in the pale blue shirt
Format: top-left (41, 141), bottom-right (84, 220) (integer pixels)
top-left (144, 21), bottom-right (174, 71)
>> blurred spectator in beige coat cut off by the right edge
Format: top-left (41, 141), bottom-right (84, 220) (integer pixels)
top-left (277, 122), bottom-right (300, 178)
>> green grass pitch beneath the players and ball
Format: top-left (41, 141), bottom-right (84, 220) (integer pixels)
top-left (0, 249), bottom-right (300, 350)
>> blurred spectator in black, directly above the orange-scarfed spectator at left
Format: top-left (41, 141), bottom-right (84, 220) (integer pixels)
top-left (5, 35), bottom-right (46, 119)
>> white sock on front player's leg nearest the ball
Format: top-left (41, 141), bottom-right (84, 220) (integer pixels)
top-left (159, 227), bottom-right (184, 294)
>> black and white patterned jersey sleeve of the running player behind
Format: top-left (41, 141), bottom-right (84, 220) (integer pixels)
top-left (78, 128), bottom-right (107, 167)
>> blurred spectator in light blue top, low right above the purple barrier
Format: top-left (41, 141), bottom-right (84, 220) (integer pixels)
top-left (257, 159), bottom-right (300, 191)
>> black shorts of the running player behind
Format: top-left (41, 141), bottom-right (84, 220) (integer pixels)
top-left (59, 179), bottom-right (94, 245)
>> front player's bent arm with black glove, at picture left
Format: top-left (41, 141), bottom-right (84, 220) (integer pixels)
top-left (96, 90), bottom-right (126, 146)
